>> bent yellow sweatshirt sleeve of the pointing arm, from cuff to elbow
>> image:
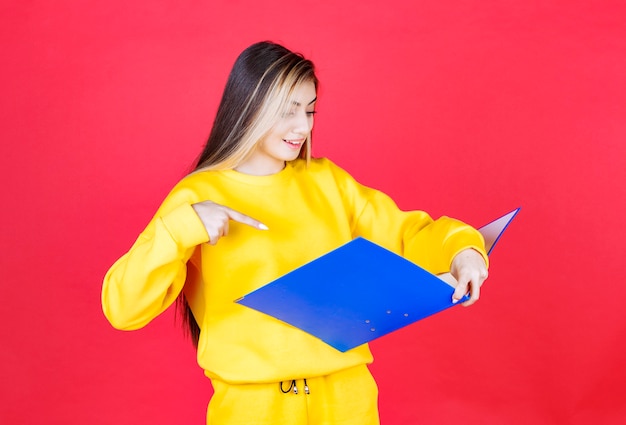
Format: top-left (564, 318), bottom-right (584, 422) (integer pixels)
top-left (102, 187), bottom-right (209, 330)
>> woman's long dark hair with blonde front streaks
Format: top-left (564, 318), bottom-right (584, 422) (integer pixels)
top-left (177, 42), bottom-right (318, 348)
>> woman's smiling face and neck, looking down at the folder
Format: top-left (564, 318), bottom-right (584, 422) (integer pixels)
top-left (236, 82), bottom-right (317, 175)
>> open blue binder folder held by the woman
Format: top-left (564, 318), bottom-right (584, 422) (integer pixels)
top-left (236, 208), bottom-right (519, 352)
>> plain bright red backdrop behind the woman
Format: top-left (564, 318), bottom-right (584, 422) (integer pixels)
top-left (0, 0), bottom-right (626, 425)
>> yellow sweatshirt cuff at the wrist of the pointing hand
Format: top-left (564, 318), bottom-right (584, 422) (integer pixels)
top-left (161, 204), bottom-right (209, 248)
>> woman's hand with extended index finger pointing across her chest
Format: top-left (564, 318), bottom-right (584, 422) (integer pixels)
top-left (191, 201), bottom-right (268, 245)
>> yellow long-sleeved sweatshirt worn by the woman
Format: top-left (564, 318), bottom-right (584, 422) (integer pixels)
top-left (102, 159), bottom-right (487, 383)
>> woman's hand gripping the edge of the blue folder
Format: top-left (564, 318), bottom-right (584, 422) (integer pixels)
top-left (450, 248), bottom-right (489, 306)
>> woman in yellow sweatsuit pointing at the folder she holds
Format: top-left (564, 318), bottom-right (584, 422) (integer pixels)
top-left (102, 42), bottom-right (487, 425)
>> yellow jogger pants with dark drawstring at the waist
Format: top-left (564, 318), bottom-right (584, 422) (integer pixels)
top-left (207, 365), bottom-right (379, 425)
